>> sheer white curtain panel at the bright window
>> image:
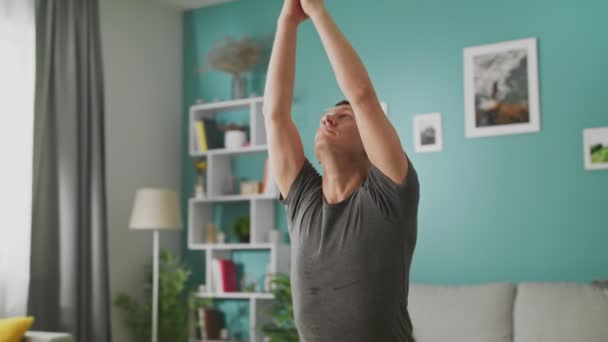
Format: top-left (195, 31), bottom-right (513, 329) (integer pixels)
top-left (0, 0), bottom-right (36, 318)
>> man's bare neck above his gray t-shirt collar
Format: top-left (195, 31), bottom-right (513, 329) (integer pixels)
top-left (322, 158), bottom-right (369, 204)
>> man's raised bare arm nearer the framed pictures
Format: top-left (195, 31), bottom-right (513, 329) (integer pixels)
top-left (300, 0), bottom-right (408, 183)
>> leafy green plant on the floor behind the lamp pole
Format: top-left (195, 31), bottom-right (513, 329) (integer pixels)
top-left (113, 250), bottom-right (195, 342)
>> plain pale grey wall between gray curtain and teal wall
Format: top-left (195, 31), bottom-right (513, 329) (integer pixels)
top-left (100, 0), bottom-right (182, 342)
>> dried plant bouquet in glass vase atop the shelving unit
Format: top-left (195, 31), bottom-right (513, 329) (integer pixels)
top-left (201, 36), bottom-right (266, 99)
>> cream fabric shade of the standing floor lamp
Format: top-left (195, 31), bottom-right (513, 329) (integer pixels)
top-left (129, 188), bottom-right (182, 230)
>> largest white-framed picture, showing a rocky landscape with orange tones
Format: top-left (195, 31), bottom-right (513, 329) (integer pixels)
top-left (463, 38), bottom-right (540, 138)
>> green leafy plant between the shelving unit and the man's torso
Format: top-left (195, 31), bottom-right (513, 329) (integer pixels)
top-left (258, 273), bottom-right (298, 342)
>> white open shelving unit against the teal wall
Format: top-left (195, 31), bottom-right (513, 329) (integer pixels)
top-left (188, 97), bottom-right (290, 342)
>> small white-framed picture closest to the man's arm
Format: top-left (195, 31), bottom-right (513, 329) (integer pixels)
top-left (414, 113), bottom-right (443, 152)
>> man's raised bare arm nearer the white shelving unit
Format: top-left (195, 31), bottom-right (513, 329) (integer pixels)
top-left (263, 0), bottom-right (307, 197)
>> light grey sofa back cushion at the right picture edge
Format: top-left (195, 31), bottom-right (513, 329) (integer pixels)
top-left (514, 283), bottom-right (608, 342)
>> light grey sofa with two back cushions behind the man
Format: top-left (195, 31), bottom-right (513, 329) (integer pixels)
top-left (408, 283), bottom-right (608, 342)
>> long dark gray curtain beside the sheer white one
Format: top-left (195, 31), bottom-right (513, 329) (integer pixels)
top-left (28, 0), bottom-right (111, 342)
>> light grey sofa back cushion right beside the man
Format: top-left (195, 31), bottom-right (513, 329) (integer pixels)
top-left (408, 283), bottom-right (515, 342)
